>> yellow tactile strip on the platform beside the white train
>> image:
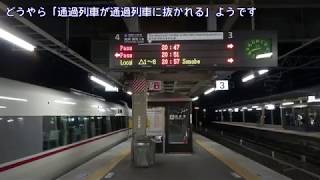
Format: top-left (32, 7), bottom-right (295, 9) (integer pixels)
top-left (87, 148), bottom-right (130, 180)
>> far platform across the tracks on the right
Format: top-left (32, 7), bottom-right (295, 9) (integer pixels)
top-left (213, 122), bottom-right (320, 139)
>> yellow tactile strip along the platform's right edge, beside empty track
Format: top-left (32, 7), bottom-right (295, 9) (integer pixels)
top-left (196, 139), bottom-right (261, 180)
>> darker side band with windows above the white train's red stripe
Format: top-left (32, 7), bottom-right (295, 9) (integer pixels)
top-left (0, 116), bottom-right (128, 163)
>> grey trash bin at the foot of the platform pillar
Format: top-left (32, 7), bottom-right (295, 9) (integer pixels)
top-left (134, 137), bottom-right (155, 167)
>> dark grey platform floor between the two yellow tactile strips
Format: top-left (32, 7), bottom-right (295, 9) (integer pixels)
top-left (112, 142), bottom-right (243, 180)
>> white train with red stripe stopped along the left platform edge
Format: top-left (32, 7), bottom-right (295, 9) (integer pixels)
top-left (0, 78), bottom-right (132, 180)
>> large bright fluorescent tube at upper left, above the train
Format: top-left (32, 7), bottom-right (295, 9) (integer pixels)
top-left (0, 28), bottom-right (36, 52)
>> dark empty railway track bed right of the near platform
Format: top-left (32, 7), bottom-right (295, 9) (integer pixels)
top-left (195, 128), bottom-right (320, 180)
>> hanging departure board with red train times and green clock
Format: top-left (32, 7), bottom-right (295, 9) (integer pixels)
top-left (109, 32), bottom-right (278, 70)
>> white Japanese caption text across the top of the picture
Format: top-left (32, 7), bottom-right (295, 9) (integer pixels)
top-left (7, 6), bottom-right (257, 18)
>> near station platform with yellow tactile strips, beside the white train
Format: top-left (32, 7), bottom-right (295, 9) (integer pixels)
top-left (58, 134), bottom-right (289, 180)
